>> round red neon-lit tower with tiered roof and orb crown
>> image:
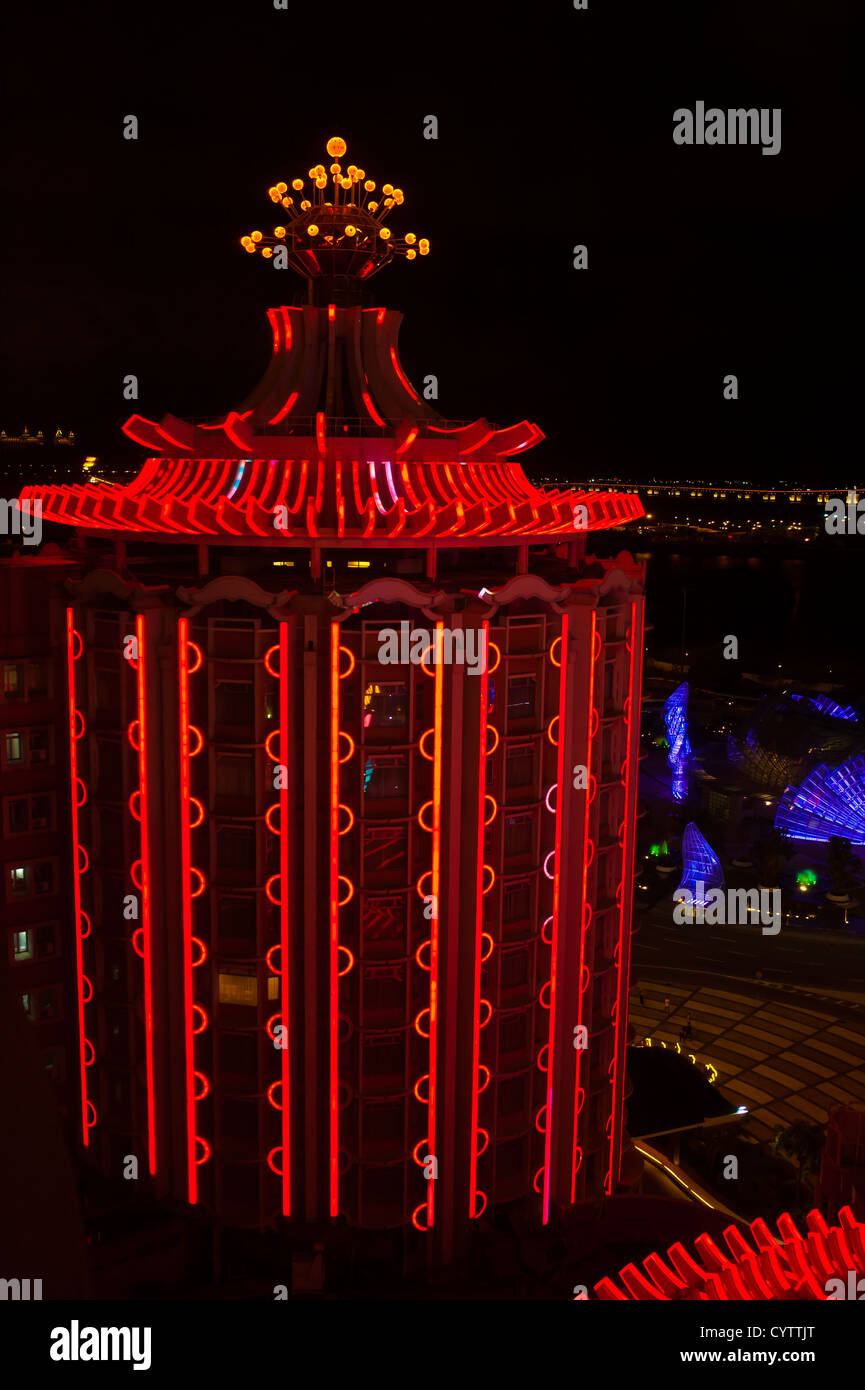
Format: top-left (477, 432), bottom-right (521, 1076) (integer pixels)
top-left (11, 140), bottom-right (644, 1264)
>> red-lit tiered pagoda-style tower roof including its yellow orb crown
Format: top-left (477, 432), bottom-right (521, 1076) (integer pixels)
top-left (22, 138), bottom-right (642, 545)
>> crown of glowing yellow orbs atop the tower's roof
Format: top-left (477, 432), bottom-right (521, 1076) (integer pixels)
top-left (241, 135), bottom-right (430, 297)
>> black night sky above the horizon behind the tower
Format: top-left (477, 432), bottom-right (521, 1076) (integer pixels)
top-left (0, 0), bottom-right (864, 487)
